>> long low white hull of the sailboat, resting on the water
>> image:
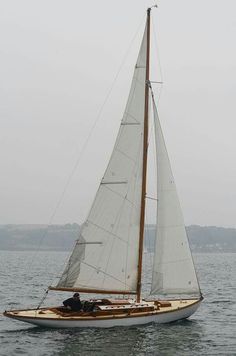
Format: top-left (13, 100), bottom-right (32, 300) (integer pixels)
top-left (5, 300), bottom-right (201, 328)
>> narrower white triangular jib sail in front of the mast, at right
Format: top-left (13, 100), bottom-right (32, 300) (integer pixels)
top-left (151, 95), bottom-right (200, 295)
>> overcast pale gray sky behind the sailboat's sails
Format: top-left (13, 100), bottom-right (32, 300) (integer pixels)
top-left (0, 0), bottom-right (236, 227)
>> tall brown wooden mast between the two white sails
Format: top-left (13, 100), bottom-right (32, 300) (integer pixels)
top-left (137, 8), bottom-right (151, 303)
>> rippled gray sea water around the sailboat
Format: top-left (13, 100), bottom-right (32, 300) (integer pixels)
top-left (0, 251), bottom-right (236, 356)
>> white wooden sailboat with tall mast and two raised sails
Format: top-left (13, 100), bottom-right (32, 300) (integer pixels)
top-left (4, 8), bottom-right (203, 328)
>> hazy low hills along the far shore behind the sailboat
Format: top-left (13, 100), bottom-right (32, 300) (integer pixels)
top-left (0, 224), bottom-right (236, 252)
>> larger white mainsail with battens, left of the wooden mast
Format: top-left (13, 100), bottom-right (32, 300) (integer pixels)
top-left (57, 24), bottom-right (147, 292)
